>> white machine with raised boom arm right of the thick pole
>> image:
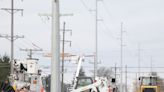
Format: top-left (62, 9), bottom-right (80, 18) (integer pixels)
top-left (71, 56), bottom-right (109, 92)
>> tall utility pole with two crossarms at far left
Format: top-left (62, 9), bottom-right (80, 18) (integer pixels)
top-left (1, 0), bottom-right (23, 75)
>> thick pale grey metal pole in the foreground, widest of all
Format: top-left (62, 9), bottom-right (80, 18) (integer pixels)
top-left (50, 0), bottom-right (61, 92)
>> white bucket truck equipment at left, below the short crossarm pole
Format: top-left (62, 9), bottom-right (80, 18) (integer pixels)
top-left (9, 59), bottom-right (44, 92)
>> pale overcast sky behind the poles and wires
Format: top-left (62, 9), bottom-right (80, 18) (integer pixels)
top-left (0, 0), bottom-right (164, 88)
